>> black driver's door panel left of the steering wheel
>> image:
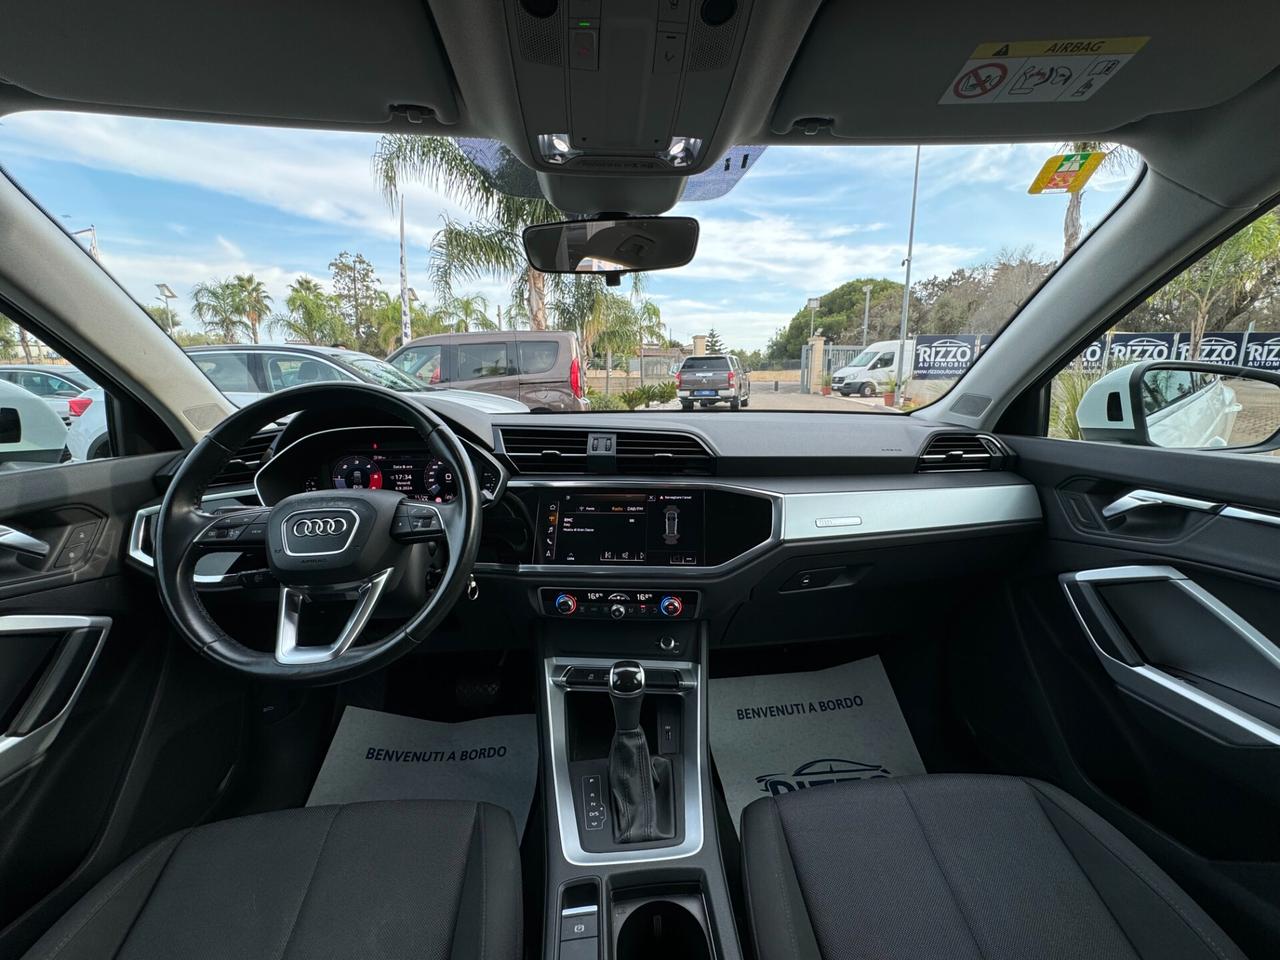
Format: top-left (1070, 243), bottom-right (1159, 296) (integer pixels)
top-left (0, 453), bottom-right (247, 960)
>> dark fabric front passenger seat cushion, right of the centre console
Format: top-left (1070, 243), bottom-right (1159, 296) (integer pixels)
top-left (742, 774), bottom-right (1244, 960)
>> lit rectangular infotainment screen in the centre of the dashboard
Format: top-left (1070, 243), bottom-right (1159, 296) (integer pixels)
top-left (538, 492), bottom-right (705, 567)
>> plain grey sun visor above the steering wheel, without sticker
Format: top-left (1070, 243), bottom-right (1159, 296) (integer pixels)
top-left (0, 0), bottom-right (458, 123)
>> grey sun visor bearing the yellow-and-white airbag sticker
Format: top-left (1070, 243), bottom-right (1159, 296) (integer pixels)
top-left (771, 0), bottom-right (1280, 142)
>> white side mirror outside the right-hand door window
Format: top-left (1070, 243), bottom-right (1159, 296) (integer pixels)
top-left (1075, 360), bottom-right (1280, 451)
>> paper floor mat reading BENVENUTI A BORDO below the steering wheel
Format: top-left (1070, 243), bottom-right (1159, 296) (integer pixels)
top-left (307, 707), bottom-right (538, 837)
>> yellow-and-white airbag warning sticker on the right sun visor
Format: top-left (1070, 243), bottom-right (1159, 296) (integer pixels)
top-left (938, 37), bottom-right (1151, 104)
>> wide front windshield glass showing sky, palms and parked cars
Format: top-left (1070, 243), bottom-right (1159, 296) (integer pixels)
top-left (0, 113), bottom-right (1140, 415)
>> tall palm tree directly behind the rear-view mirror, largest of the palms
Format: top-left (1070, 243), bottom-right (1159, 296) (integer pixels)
top-left (374, 133), bottom-right (563, 330)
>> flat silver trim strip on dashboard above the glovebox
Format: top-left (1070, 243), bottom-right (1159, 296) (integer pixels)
top-left (782, 484), bottom-right (1041, 540)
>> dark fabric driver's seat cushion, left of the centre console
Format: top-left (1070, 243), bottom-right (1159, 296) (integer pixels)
top-left (27, 800), bottom-right (521, 960)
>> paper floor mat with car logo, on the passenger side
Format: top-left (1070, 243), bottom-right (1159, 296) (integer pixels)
top-left (709, 657), bottom-right (924, 827)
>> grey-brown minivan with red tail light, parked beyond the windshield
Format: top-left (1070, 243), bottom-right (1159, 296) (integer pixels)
top-left (387, 330), bottom-right (590, 411)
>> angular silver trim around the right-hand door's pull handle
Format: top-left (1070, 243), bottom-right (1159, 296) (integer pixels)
top-left (1064, 566), bottom-right (1280, 748)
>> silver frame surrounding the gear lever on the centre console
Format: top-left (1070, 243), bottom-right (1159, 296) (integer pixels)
top-left (543, 657), bottom-right (707, 867)
